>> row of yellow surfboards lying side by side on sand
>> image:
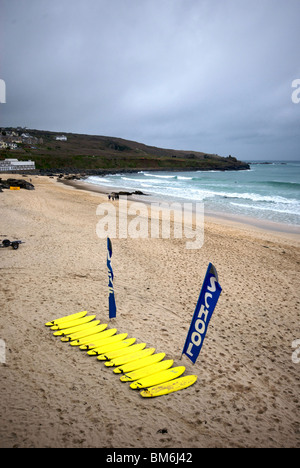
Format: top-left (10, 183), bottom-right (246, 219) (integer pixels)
top-left (45, 311), bottom-right (197, 398)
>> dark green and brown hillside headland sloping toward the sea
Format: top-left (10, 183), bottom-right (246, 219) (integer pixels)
top-left (0, 128), bottom-right (249, 172)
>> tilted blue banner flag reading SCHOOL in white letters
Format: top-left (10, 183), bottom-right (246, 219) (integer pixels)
top-left (182, 263), bottom-right (222, 364)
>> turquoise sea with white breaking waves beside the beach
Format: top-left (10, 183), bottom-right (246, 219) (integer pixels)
top-left (86, 161), bottom-right (300, 233)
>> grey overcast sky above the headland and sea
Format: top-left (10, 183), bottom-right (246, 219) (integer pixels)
top-left (0, 0), bottom-right (300, 160)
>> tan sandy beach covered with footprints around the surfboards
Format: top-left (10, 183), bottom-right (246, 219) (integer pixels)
top-left (0, 176), bottom-right (300, 448)
